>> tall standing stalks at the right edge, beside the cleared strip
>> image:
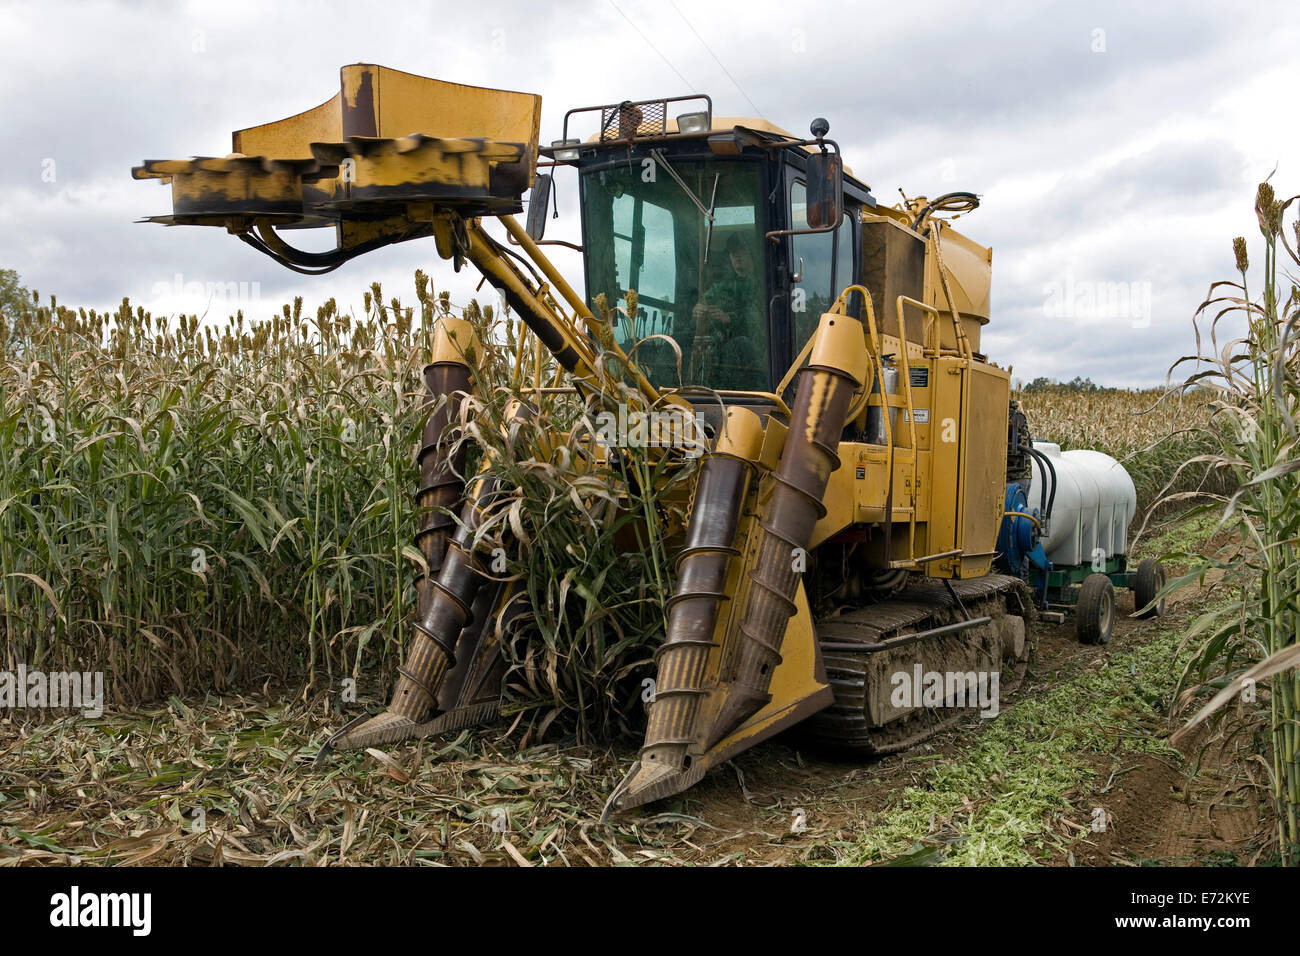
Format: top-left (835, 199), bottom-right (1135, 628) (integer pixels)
top-left (1167, 182), bottom-right (1300, 865)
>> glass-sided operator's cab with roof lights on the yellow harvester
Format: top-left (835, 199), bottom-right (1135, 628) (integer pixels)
top-left (542, 98), bottom-right (875, 405)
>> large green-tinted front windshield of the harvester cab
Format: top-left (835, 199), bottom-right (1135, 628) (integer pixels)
top-left (582, 156), bottom-right (768, 390)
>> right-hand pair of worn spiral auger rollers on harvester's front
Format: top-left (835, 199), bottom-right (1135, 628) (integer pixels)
top-left (606, 312), bottom-right (867, 813)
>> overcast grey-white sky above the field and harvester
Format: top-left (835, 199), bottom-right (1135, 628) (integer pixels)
top-left (0, 0), bottom-right (1300, 385)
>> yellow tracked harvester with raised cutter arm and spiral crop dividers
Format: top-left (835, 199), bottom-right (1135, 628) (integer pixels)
top-left (134, 64), bottom-right (1170, 810)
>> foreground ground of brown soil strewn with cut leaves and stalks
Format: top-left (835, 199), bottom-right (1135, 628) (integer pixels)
top-left (0, 515), bottom-right (1271, 866)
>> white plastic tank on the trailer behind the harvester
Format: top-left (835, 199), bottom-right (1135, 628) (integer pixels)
top-left (1028, 441), bottom-right (1138, 564)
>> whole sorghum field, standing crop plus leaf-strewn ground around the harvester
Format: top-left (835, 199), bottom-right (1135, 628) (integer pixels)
top-left (0, 180), bottom-right (1300, 865)
